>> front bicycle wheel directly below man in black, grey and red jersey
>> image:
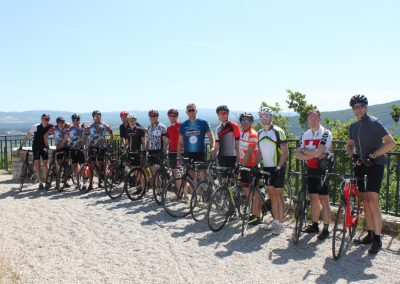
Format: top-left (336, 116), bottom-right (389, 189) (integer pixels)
top-left (206, 186), bottom-right (234, 232)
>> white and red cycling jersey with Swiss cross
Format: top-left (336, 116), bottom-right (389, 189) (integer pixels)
top-left (300, 125), bottom-right (332, 169)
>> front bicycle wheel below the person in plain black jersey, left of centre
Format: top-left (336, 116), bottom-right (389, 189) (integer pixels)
top-left (124, 168), bottom-right (147, 201)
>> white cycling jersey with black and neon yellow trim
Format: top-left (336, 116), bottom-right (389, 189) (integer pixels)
top-left (258, 125), bottom-right (287, 168)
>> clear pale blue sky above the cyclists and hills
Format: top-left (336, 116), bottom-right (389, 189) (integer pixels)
top-left (0, 0), bottom-right (400, 112)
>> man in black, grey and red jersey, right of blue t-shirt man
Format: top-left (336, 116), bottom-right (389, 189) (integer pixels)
top-left (212, 105), bottom-right (240, 167)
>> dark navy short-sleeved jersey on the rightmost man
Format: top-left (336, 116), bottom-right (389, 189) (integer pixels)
top-left (349, 114), bottom-right (389, 165)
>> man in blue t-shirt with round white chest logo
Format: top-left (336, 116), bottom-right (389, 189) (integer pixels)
top-left (177, 103), bottom-right (215, 164)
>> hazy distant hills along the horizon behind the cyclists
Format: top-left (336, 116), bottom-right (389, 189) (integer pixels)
top-left (0, 100), bottom-right (400, 136)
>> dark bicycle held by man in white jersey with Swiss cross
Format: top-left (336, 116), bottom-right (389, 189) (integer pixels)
top-left (288, 172), bottom-right (328, 245)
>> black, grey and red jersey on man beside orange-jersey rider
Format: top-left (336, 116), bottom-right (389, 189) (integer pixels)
top-left (215, 121), bottom-right (240, 156)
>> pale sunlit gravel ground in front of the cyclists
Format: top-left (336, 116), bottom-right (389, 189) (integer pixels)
top-left (0, 175), bottom-right (400, 283)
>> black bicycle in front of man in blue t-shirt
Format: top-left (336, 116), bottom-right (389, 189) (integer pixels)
top-left (162, 158), bottom-right (206, 218)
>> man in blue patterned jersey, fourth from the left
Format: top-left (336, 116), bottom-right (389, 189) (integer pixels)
top-left (82, 110), bottom-right (114, 188)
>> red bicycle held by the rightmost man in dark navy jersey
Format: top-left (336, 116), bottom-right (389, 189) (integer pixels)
top-left (330, 174), bottom-right (367, 260)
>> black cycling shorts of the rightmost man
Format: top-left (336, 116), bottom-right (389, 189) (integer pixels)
top-left (354, 164), bottom-right (385, 194)
